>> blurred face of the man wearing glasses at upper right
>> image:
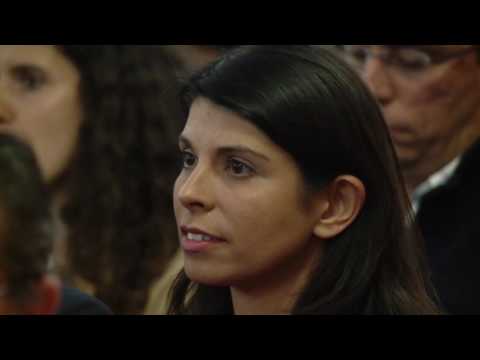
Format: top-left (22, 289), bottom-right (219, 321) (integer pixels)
top-left (343, 45), bottom-right (480, 185)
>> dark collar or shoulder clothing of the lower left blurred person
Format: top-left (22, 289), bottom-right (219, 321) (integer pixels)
top-left (57, 288), bottom-right (112, 315)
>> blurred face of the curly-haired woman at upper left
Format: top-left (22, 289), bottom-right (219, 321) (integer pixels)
top-left (0, 45), bottom-right (82, 182)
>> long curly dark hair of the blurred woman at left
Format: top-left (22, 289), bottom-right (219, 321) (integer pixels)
top-left (56, 45), bottom-right (181, 314)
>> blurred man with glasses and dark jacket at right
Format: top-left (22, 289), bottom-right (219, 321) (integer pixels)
top-left (340, 45), bottom-right (480, 314)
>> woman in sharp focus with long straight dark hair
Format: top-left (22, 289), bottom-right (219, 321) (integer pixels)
top-left (169, 46), bottom-right (440, 315)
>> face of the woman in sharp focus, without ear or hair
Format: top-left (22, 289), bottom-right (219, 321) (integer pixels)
top-left (174, 98), bottom-right (321, 287)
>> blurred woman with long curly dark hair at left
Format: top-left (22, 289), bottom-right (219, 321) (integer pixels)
top-left (0, 45), bottom-right (180, 313)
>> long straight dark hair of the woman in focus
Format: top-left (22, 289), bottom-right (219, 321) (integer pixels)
top-left (170, 45), bottom-right (439, 314)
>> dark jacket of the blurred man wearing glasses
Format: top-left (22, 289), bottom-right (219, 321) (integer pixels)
top-left (417, 142), bottom-right (480, 315)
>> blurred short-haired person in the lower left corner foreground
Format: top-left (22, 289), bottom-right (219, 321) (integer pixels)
top-left (0, 134), bottom-right (111, 315)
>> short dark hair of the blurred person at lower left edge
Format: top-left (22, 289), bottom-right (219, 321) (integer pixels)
top-left (0, 134), bottom-right (53, 304)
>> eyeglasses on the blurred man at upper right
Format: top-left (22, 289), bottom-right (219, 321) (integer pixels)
top-left (341, 45), bottom-right (478, 75)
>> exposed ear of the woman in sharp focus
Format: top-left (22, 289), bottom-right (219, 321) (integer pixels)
top-left (314, 176), bottom-right (366, 239)
